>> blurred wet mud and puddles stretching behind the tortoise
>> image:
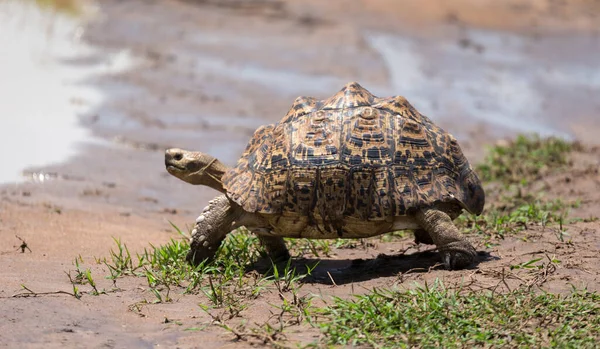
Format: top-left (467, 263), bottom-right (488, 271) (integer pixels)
top-left (0, 0), bottom-right (600, 215)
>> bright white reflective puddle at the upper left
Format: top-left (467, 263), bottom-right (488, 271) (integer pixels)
top-left (0, 1), bottom-right (133, 182)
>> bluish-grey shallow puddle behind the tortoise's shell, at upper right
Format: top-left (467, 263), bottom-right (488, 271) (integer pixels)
top-left (366, 30), bottom-right (600, 139)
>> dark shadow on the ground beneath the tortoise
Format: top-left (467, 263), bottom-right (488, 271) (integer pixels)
top-left (250, 251), bottom-right (499, 285)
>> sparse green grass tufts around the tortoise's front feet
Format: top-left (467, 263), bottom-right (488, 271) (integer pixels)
top-left (92, 225), bottom-right (314, 309)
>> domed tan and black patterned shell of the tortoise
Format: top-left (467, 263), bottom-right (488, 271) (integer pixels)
top-left (223, 83), bottom-right (485, 223)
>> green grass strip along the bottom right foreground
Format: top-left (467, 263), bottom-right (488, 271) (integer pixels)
top-left (319, 283), bottom-right (600, 348)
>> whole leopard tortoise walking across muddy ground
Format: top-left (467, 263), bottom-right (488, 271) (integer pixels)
top-left (165, 82), bottom-right (485, 269)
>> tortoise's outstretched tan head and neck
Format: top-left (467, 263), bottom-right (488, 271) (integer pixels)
top-left (165, 148), bottom-right (228, 193)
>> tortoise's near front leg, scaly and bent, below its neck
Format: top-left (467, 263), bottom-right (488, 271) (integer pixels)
top-left (185, 195), bottom-right (243, 265)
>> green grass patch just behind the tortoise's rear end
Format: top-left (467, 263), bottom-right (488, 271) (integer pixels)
top-left (456, 135), bottom-right (579, 240)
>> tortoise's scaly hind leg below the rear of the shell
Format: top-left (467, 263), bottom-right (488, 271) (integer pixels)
top-left (415, 208), bottom-right (477, 270)
